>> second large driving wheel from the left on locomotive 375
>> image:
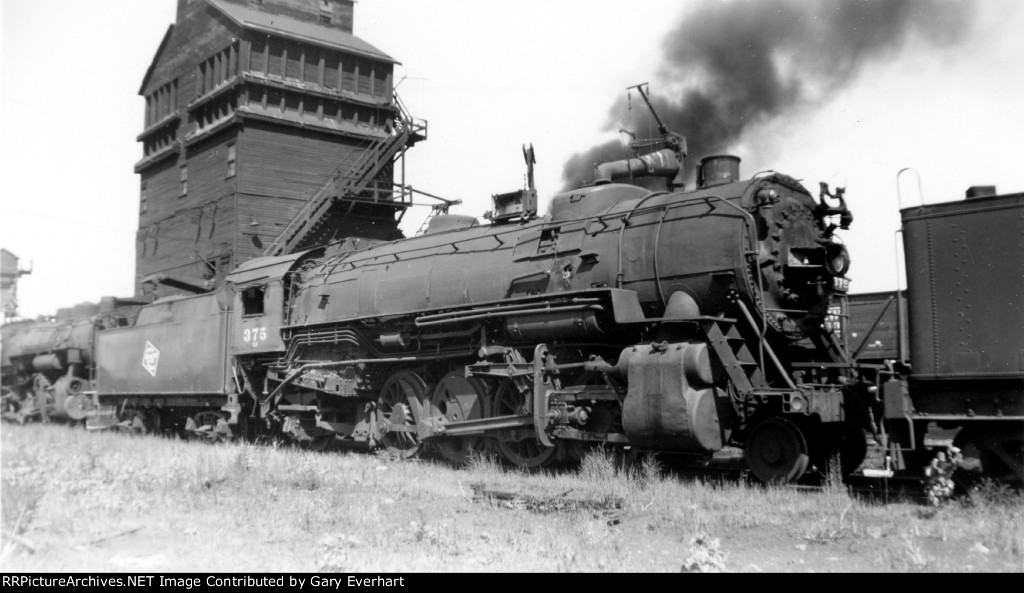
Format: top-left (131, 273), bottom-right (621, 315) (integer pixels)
top-left (430, 370), bottom-right (489, 465)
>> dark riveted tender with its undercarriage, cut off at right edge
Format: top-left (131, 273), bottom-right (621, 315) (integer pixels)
top-left (849, 186), bottom-right (1024, 483)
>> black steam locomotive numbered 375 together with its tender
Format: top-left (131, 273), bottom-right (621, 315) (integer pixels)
top-left (86, 138), bottom-right (873, 482)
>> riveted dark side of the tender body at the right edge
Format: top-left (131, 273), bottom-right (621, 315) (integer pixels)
top-left (903, 195), bottom-right (1024, 378)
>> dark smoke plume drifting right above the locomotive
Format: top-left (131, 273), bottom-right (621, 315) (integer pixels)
top-left (562, 0), bottom-right (972, 189)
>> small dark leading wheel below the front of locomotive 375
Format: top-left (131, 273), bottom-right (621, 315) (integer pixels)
top-left (744, 418), bottom-right (809, 483)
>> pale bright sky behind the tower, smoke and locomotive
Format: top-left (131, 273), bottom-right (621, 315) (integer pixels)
top-left (0, 0), bottom-right (1024, 317)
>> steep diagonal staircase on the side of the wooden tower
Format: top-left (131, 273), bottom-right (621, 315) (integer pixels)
top-left (263, 113), bottom-right (426, 256)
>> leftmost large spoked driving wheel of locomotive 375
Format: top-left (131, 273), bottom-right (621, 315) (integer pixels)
top-left (377, 371), bottom-right (427, 459)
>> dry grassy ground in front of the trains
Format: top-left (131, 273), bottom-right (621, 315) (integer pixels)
top-left (0, 425), bottom-right (1024, 571)
